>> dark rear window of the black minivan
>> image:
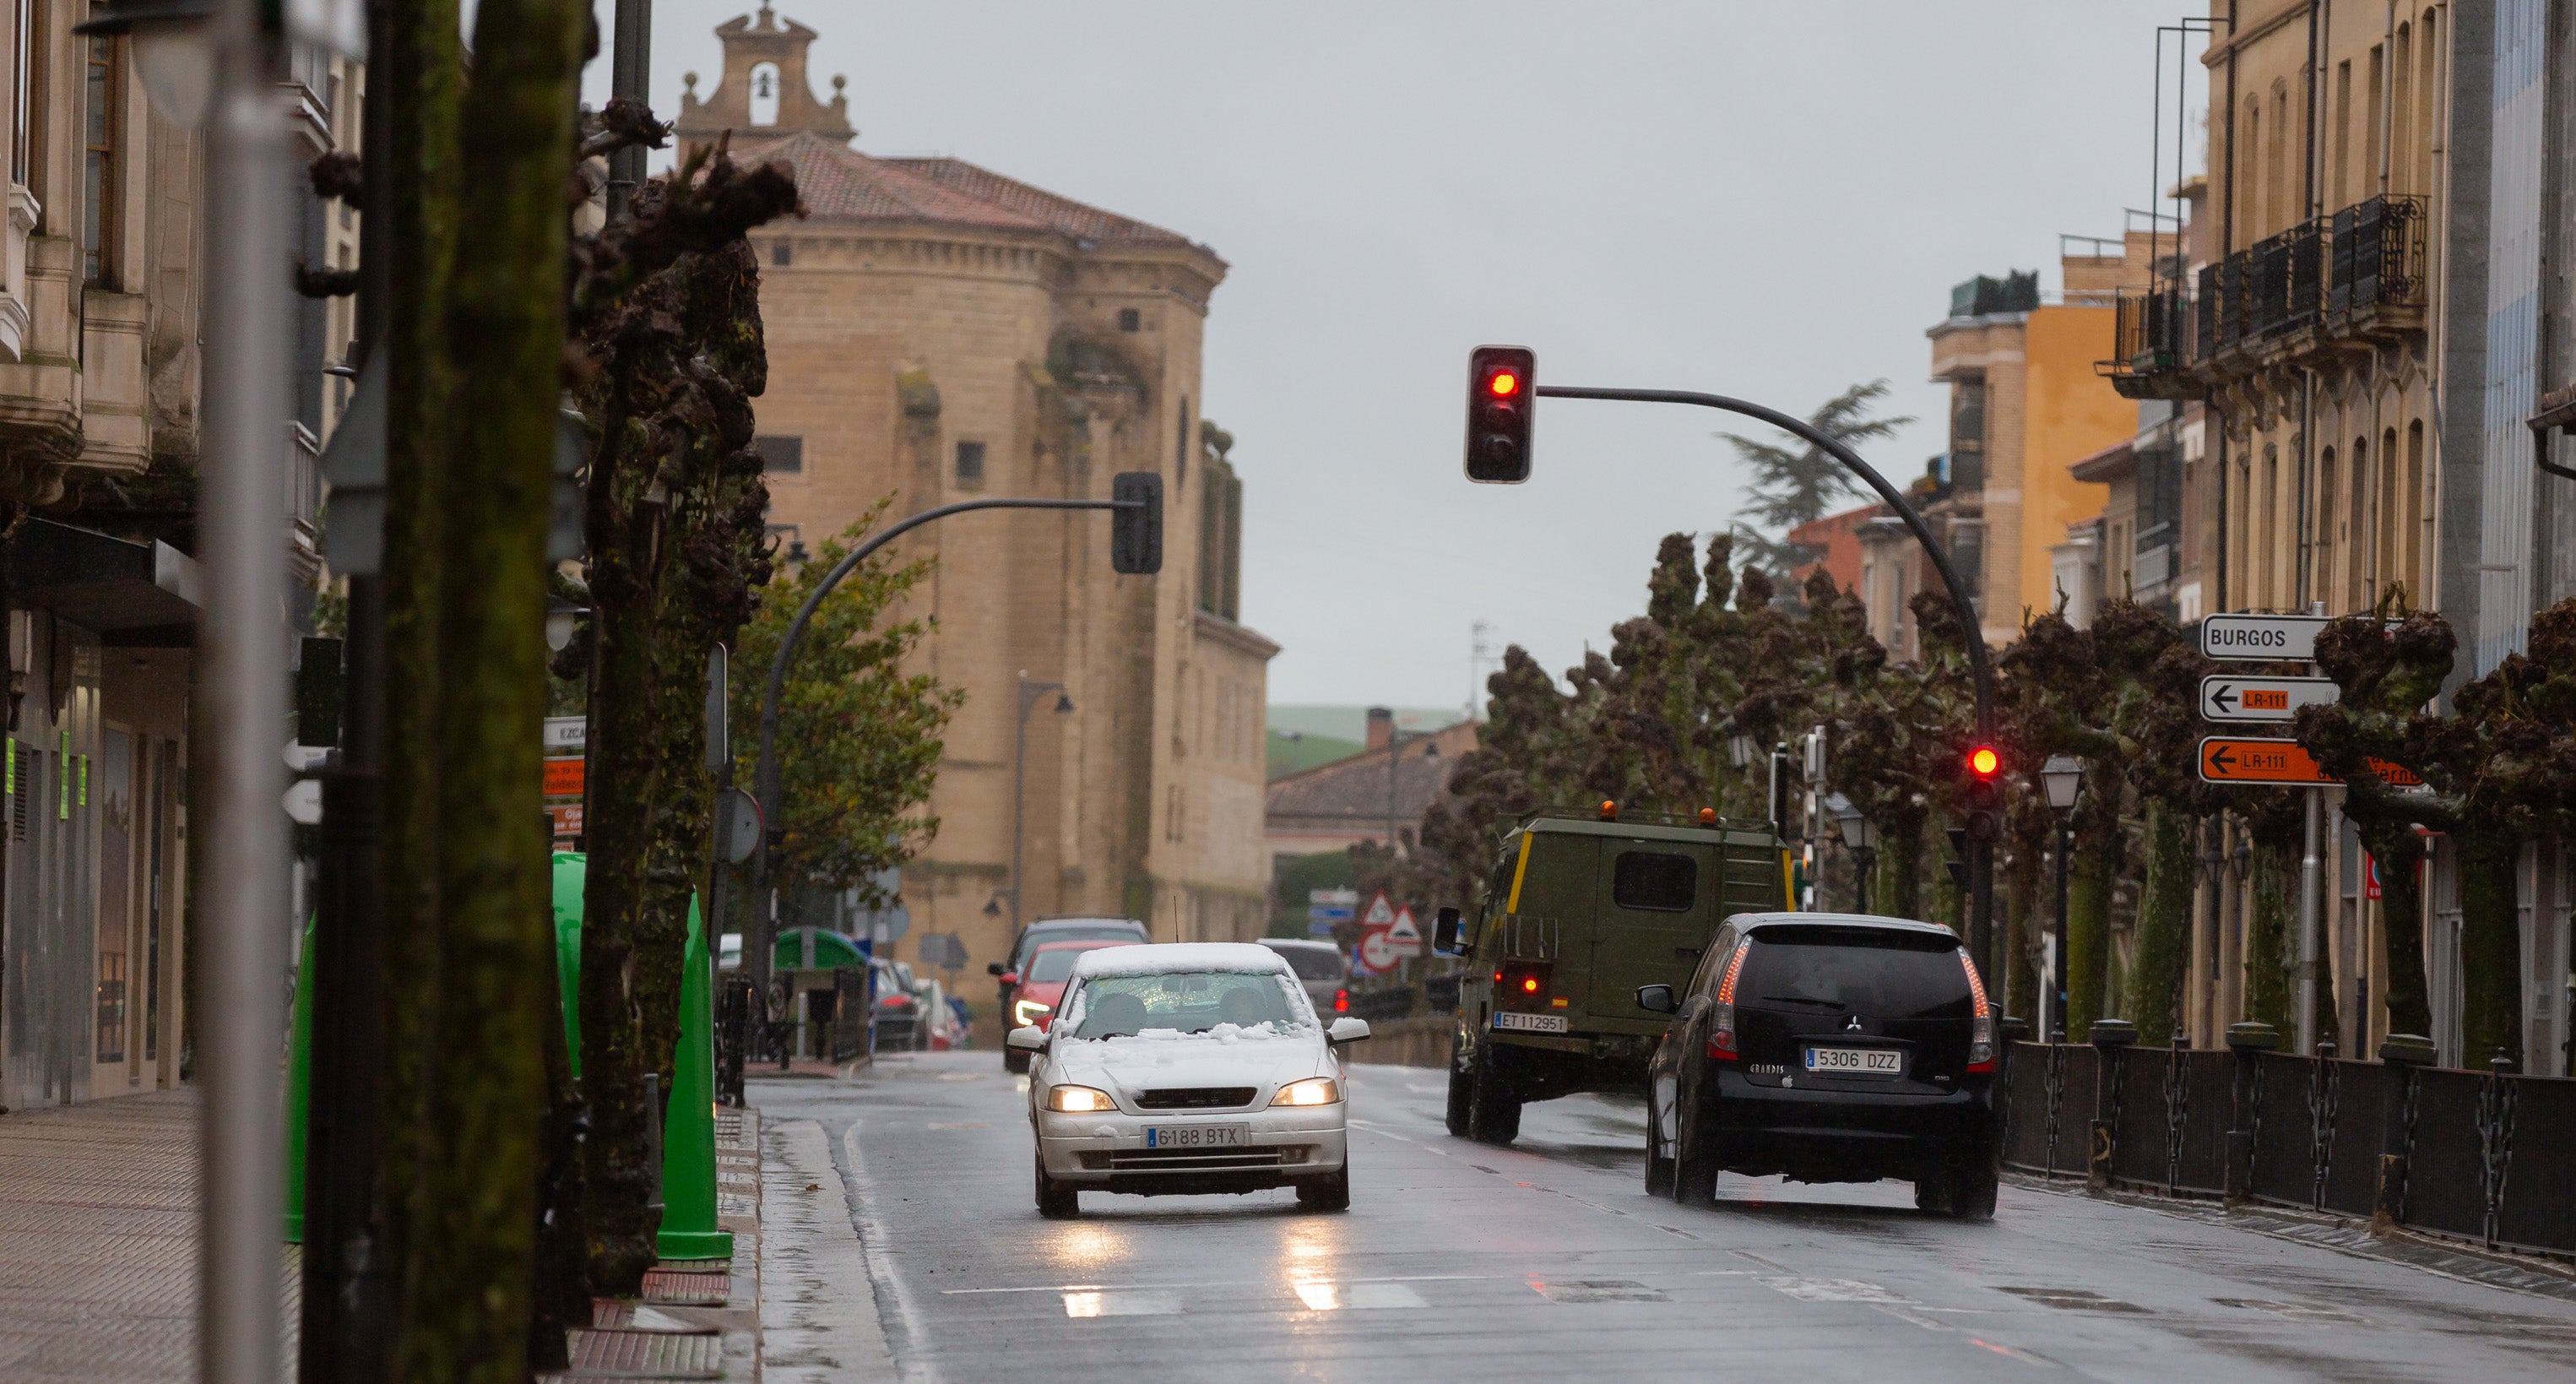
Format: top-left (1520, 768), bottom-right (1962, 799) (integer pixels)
top-left (1736, 925), bottom-right (1971, 1018)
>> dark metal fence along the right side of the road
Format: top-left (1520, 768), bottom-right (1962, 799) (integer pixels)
top-left (2004, 1041), bottom-right (2576, 1255)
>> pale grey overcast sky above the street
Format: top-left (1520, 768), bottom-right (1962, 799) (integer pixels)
top-left (593, 0), bottom-right (2198, 703)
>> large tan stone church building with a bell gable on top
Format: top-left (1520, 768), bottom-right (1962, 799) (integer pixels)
top-left (680, 8), bottom-right (1277, 1000)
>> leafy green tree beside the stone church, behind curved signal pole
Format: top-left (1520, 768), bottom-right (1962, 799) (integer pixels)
top-left (731, 500), bottom-right (966, 904)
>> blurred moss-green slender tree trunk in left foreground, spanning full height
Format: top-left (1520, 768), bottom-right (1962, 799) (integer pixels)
top-left (402, 0), bottom-right (588, 1384)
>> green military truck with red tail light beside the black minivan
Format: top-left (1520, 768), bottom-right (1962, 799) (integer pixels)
top-left (1432, 801), bottom-right (1792, 1144)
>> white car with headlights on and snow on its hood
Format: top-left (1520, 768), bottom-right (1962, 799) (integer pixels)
top-left (1005, 943), bottom-right (1368, 1219)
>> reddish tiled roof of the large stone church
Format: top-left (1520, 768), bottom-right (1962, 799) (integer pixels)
top-left (735, 132), bottom-right (1190, 250)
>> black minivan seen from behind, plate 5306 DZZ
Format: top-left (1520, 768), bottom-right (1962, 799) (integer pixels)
top-left (1635, 912), bottom-right (1999, 1219)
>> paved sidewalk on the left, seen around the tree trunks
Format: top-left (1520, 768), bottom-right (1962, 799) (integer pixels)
top-left (0, 1088), bottom-right (798, 1384)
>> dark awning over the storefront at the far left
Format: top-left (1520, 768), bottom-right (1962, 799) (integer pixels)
top-left (8, 518), bottom-right (203, 649)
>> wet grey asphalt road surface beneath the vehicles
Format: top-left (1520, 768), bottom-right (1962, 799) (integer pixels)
top-left (752, 1051), bottom-right (2576, 1384)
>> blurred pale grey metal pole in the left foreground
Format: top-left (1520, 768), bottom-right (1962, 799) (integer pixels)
top-left (191, 0), bottom-right (294, 1384)
